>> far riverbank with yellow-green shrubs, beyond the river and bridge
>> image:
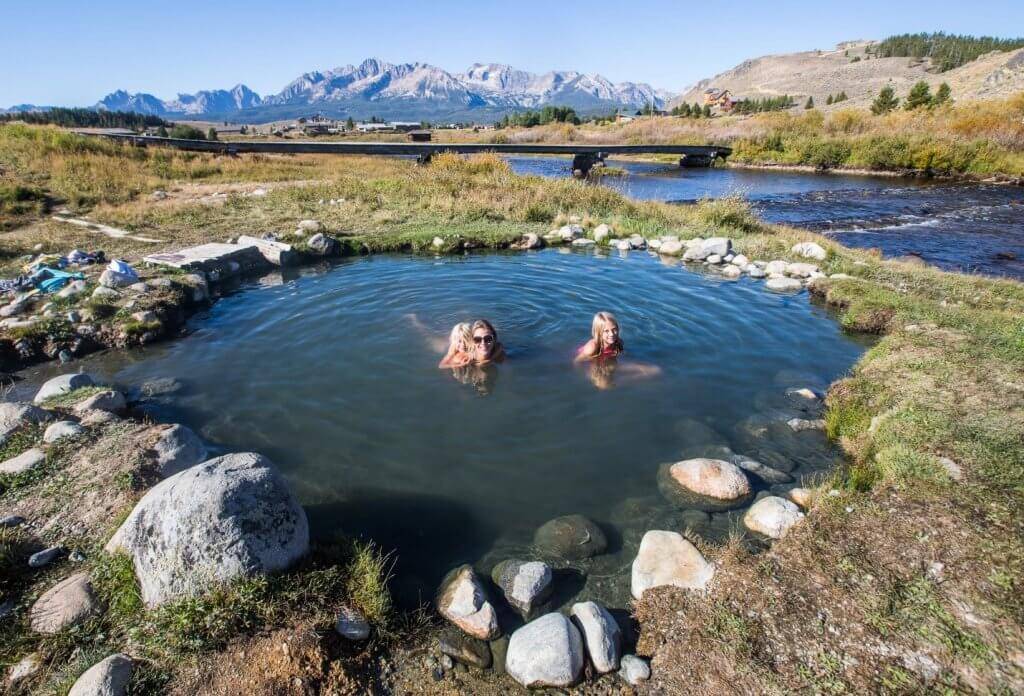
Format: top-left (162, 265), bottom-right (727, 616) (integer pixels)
top-left (450, 94), bottom-right (1024, 178)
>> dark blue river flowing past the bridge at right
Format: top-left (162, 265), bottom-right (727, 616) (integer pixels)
top-left (509, 157), bottom-right (1024, 279)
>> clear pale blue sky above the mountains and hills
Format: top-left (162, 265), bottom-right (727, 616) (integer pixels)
top-left (0, 0), bottom-right (1024, 106)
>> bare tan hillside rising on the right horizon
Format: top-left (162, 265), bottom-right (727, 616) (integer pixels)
top-left (670, 40), bottom-right (1024, 108)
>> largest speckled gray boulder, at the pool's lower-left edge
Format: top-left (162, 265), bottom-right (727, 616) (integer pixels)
top-left (106, 452), bottom-right (309, 607)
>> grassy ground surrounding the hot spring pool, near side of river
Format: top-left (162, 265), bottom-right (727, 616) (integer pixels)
top-left (0, 126), bottom-right (1024, 693)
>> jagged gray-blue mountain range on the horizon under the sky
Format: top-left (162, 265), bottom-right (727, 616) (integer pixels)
top-left (10, 58), bottom-right (672, 123)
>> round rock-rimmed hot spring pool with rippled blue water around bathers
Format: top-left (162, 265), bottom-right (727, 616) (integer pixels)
top-left (18, 251), bottom-right (863, 607)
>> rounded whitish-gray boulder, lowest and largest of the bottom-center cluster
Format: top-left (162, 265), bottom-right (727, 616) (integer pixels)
top-left (505, 613), bottom-right (584, 688)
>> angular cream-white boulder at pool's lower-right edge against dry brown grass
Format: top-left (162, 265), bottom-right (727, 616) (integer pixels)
top-left (631, 530), bottom-right (715, 599)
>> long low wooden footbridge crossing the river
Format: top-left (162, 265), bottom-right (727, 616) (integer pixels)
top-left (91, 133), bottom-right (732, 176)
